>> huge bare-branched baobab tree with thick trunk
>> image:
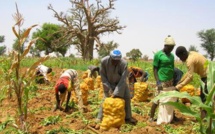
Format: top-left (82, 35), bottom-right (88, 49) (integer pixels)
top-left (48, 0), bottom-right (125, 60)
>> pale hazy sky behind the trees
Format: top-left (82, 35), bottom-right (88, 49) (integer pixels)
top-left (0, 0), bottom-right (215, 58)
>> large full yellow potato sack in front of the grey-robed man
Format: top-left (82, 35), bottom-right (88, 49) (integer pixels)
top-left (100, 97), bottom-right (125, 130)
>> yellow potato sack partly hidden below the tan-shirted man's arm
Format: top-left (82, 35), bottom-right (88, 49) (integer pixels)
top-left (180, 84), bottom-right (197, 103)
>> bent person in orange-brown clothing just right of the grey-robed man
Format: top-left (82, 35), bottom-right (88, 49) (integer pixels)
top-left (128, 66), bottom-right (149, 98)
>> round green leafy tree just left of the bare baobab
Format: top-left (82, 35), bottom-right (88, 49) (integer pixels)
top-left (31, 23), bottom-right (70, 56)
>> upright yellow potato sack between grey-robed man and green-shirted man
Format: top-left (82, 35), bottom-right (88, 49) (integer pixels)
top-left (132, 82), bottom-right (149, 102)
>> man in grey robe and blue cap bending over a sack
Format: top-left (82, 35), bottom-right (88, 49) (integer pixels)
top-left (97, 50), bottom-right (136, 124)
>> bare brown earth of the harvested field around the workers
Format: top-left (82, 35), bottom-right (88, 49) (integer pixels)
top-left (0, 68), bottom-right (199, 134)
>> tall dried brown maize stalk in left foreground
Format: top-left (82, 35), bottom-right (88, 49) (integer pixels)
top-left (8, 5), bottom-right (48, 132)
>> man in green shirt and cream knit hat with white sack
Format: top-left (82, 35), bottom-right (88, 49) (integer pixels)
top-left (150, 36), bottom-right (176, 125)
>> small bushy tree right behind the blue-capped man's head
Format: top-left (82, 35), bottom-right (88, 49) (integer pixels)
top-left (96, 41), bottom-right (119, 58)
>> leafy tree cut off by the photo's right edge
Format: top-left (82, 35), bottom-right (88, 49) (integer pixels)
top-left (198, 29), bottom-right (215, 61)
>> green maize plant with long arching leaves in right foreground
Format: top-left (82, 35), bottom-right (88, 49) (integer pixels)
top-left (152, 62), bottom-right (215, 134)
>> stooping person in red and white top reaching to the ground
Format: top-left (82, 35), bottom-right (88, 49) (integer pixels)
top-left (54, 69), bottom-right (83, 112)
